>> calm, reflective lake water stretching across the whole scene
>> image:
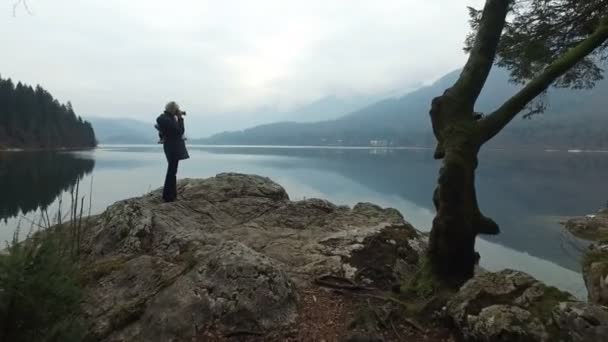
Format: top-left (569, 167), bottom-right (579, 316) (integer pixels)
top-left (0, 146), bottom-right (608, 297)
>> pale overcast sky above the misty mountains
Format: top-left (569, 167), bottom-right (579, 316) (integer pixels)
top-left (0, 0), bottom-right (483, 133)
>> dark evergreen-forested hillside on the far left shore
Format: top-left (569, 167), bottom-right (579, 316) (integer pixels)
top-left (0, 78), bottom-right (97, 148)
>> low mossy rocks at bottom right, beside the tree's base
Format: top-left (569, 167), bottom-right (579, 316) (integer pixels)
top-left (447, 270), bottom-right (608, 342)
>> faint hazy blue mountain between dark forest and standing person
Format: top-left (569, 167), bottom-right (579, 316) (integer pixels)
top-left (89, 117), bottom-right (158, 144)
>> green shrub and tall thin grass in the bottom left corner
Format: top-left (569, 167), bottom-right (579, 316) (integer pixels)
top-left (0, 182), bottom-right (91, 342)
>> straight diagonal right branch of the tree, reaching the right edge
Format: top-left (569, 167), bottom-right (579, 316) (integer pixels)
top-left (479, 18), bottom-right (608, 143)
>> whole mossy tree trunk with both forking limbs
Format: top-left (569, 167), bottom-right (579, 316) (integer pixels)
top-left (428, 0), bottom-right (608, 285)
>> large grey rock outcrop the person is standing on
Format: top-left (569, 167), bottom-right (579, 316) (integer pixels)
top-left (78, 174), bottom-right (426, 341)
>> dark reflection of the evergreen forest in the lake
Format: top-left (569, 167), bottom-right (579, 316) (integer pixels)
top-left (0, 152), bottom-right (95, 222)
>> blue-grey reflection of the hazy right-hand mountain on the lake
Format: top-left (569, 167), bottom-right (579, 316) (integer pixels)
top-left (194, 148), bottom-right (608, 272)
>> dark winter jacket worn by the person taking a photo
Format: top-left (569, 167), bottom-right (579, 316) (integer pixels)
top-left (156, 113), bottom-right (190, 160)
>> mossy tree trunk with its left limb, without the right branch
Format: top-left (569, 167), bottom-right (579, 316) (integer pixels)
top-left (428, 0), bottom-right (510, 285)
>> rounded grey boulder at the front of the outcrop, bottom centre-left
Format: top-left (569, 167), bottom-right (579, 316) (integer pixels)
top-left (109, 241), bottom-right (297, 341)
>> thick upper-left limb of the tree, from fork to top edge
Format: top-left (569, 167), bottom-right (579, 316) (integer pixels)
top-left (448, 0), bottom-right (511, 107)
